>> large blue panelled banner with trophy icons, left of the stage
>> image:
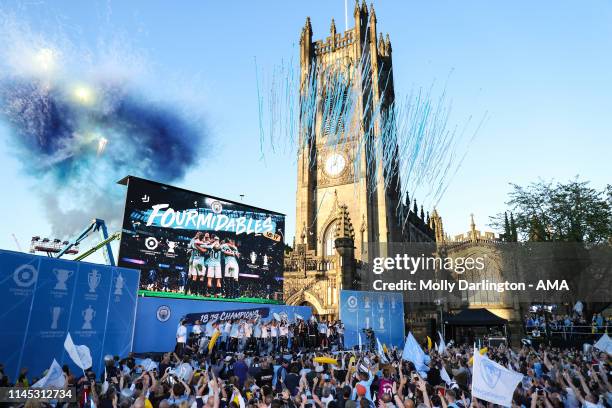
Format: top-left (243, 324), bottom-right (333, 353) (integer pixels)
top-left (0, 250), bottom-right (140, 381)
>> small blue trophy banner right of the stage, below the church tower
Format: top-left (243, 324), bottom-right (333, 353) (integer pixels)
top-left (340, 290), bottom-right (404, 347)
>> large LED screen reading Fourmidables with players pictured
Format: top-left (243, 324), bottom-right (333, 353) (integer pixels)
top-left (119, 177), bottom-right (285, 302)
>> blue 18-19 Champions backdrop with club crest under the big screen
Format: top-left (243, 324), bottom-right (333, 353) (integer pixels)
top-left (134, 297), bottom-right (312, 353)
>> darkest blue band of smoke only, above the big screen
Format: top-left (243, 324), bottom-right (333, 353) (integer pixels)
top-left (0, 79), bottom-right (204, 182)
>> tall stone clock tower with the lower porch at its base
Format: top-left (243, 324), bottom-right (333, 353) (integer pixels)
top-left (284, 3), bottom-right (435, 318)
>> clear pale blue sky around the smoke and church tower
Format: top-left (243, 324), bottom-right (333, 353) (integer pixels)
top-left (0, 0), bottom-right (612, 256)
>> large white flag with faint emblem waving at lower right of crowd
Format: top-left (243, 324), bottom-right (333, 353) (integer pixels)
top-left (472, 349), bottom-right (523, 407)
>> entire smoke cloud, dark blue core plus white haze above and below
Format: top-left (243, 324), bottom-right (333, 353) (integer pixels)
top-left (0, 11), bottom-right (207, 238)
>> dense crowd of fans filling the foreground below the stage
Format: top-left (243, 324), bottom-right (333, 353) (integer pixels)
top-left (0, 328), bottom-right (612, 408)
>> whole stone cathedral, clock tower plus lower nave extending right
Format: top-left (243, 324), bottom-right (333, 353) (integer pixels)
top-left (283, 3), bottom-right (519, 335)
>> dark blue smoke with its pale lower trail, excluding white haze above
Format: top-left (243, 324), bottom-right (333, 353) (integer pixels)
top-left (0, 77), bottom-right (205, 236)
